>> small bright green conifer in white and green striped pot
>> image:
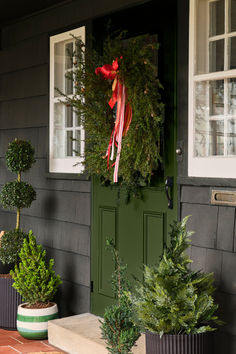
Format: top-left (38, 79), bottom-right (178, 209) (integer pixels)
top-left (10, 231), bottom-right (61, 339)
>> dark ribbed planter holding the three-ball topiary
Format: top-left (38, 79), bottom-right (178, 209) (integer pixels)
top-left (0, 277), bottom-right (22, 329)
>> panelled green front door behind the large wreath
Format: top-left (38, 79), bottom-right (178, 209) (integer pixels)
top-left (91, 0), bottom-right (177, 315)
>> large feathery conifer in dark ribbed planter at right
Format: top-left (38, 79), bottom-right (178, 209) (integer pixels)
top-left (131, 217), bottom-right (222, 354)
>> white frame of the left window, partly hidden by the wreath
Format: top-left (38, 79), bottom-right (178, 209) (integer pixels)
top-left (49, 26), bottom-right (85, 174)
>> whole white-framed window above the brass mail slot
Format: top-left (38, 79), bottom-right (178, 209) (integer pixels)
top-left (188, 0), bottom-right (236, 178)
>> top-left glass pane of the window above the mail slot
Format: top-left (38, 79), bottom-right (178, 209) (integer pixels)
top-left (209, 0), bottom-right (225, 37)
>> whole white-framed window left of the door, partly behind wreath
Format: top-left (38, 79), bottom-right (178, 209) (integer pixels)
top-left (49, 27), bottom-right (85, 173)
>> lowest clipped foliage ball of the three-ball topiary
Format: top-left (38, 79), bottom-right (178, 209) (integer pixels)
top-left (0, 229), bottom-right (28, 264)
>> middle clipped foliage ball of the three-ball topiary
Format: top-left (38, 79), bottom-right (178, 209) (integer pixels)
top-left (0, 181), bottom-right (36, 209)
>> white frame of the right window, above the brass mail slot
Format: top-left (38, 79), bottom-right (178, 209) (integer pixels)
top-left (188, 0), bottom-right (236, 178)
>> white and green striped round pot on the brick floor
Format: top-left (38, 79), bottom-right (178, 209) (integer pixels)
top-left (17, 304), bottom-right (58, 339)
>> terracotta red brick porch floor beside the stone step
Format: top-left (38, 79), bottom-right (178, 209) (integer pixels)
top-left (0, 329), bottom-right (65, 354)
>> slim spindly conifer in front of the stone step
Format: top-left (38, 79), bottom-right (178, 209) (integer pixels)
top-left (101, 241), bottom-right (140, 354)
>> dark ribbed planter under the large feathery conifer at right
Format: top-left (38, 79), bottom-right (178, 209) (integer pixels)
top-left (146, 332), bottom-right (213, 354)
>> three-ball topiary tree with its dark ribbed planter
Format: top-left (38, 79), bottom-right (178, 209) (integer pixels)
top-left (0, 139), bottom-right (36, 329)
